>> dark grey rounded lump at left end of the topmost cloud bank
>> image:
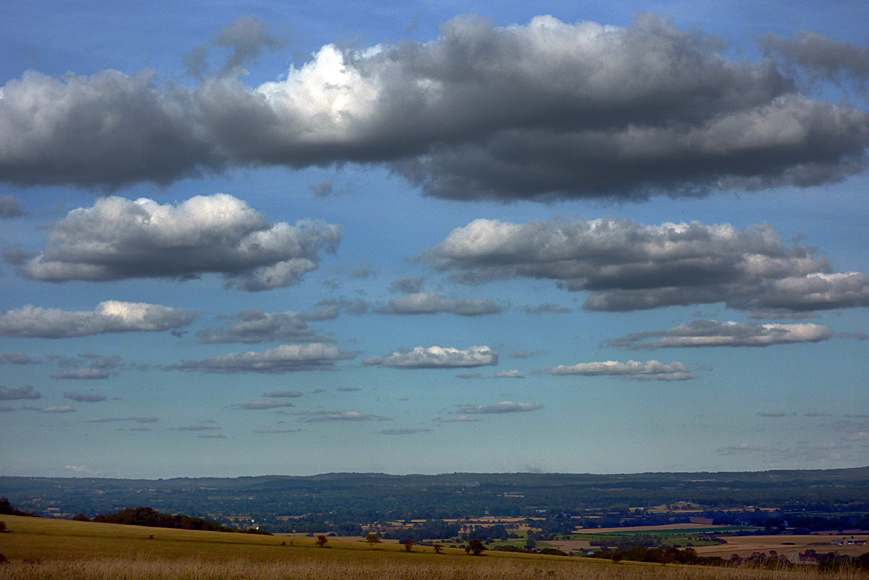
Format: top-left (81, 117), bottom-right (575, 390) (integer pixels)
top-left (0, 71), bottom-right (219, 189)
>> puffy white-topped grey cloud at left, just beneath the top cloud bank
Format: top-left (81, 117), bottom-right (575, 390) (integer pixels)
top-left (18, 194), bottom-right (341, 291)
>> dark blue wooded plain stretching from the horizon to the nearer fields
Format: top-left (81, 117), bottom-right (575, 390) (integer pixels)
top-left (0, 468), bottom-right (869, 535)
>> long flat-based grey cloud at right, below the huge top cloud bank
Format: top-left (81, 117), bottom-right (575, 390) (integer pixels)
top-left (418, 217), bottom-right (869, 317)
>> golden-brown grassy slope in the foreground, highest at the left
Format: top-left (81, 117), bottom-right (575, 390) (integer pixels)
top-left (0, 516), bottom-right (869, 580)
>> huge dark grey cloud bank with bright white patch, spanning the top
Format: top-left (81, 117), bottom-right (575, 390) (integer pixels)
top-left (0, 16), bottom-right (869, 200)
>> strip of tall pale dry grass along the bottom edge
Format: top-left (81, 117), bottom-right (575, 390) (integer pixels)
top-left (0, 557), bottom-right (856, 580)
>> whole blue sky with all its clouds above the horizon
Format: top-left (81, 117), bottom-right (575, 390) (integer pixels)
top-left (0, 0), bottom-right (869, 478)
